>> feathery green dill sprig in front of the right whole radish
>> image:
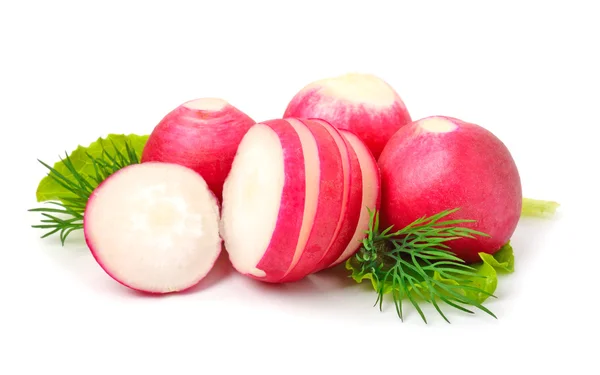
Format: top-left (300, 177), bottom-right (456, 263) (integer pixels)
top-left (348, 208), bottom-right (496, 323)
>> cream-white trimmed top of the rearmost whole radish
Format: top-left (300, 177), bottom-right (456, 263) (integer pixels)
top-left (317, 73), bottom-right (397, 107)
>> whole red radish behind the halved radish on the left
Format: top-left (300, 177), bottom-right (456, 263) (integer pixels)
top-left (142, 98), bottom-right (255, 200)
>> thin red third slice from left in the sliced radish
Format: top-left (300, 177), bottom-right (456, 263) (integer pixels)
top-left (314, 119), bottom-right (363, 272)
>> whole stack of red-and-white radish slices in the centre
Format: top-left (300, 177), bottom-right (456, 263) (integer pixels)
top-left (221, 118), bottom-right (379, 282)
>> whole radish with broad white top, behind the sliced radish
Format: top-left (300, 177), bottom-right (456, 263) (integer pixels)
top-left (284, 73), bottom-right (411, 158)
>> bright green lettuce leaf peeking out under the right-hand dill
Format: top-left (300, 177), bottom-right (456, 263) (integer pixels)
top-left (346, 242), bottom-right (515, 303)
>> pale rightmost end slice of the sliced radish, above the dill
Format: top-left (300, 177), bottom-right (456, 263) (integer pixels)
top-left (329, 130), bottom-right (381, 267)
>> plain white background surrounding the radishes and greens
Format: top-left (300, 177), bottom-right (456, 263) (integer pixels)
top-left (0, 0), bottom-right (600, 375)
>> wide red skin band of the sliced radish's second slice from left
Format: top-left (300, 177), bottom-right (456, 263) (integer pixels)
top-left (280, 118), bottom-right (344, 282)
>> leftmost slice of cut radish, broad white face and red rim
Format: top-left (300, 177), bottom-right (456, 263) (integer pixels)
top-left (221, 120), bottom-right (308, 282)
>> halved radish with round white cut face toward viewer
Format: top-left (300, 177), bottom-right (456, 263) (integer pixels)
top-left (84, 162), bottom-right (222, 294)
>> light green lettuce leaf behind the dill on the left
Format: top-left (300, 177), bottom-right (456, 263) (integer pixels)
top-left (36, 134), bottom-right (148, 202)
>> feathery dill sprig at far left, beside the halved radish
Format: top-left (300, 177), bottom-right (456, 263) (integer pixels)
top-left (29, 140), bottom-right (140, 246)
